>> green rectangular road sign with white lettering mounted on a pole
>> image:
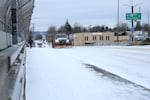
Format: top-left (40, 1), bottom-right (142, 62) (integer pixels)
top-left (126, 13), bottom-right (141, 20)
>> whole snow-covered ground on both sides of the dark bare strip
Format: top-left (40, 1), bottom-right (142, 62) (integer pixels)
top-left (26, 46), bottom-right (150, 100)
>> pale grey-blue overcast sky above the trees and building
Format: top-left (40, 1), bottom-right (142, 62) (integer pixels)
top-left (31, 0), bottom-right (150, 31)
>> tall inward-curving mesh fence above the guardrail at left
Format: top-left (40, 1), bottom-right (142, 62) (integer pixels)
top-left (0, 0), bottom-right (34, 50)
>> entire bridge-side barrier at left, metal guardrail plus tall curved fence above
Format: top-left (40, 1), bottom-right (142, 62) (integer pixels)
top-left (0, 0), bottom-right (34, 100)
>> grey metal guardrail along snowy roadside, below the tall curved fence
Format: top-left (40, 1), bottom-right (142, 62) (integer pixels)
top-left (0, 42), bottom-right (26, 100)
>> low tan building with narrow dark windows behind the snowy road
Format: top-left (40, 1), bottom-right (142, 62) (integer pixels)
top-left (73, 32), bottom-right (130, 46)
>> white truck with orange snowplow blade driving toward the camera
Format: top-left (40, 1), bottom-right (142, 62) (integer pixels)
top-left (52, 34), bottom-right (72, 48)
